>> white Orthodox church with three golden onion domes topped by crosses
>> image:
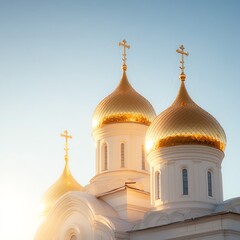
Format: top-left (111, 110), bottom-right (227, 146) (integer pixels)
top-left (34, 40), bottom-right (240, 240)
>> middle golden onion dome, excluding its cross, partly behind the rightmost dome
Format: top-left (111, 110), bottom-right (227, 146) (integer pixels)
top-left (92, 69), bottom-right (156, 129)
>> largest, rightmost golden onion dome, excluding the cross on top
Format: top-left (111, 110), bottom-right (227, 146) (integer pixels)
top-left (146, 81), bottom-right (226, 153)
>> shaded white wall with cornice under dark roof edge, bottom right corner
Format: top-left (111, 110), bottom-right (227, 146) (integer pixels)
top-left (130, 213), bottom-right (240, 240)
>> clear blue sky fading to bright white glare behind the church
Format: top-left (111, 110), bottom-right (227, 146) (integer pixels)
top-left (0, 0), bottom-right (240, 240)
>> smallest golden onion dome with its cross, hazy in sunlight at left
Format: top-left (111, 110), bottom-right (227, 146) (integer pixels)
top-left (42, 131), bottom-right (83, 215)
